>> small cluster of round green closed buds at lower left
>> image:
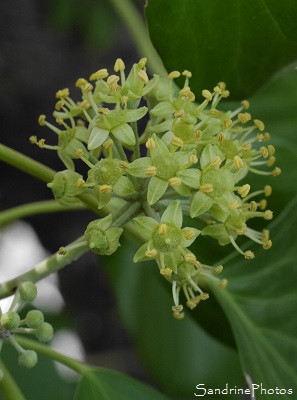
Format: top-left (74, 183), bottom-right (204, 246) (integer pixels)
top-left (0, 281), bottom-right (53, 375)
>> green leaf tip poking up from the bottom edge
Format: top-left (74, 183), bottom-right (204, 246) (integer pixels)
top-left (74, 368), bottom-right (166, 400)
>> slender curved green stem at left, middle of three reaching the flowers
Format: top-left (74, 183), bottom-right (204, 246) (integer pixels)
top-left (0, 200), bottom-right (85, 227)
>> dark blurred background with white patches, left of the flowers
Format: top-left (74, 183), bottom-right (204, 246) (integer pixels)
top-left (0, 0), bottom-right (146, 390)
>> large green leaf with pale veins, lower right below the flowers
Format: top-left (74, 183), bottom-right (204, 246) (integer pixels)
top-left (208, 196), bottom-right (297, 400)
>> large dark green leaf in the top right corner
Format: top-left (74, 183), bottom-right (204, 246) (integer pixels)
top-left (146, 0), bottom-right (297, 99)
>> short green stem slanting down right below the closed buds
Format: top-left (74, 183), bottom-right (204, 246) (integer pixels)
top-left (13, 336), bottom-right (88, 374)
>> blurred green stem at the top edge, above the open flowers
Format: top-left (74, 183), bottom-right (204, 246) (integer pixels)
top-left (109, 0), bottom-right (167, 76)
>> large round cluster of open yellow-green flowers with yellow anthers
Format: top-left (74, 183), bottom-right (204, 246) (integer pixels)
top-left (30, 58), bottom-right (280, 318)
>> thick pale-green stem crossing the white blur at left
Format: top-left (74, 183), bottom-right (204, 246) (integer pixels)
top-left (0, 237), bottom-right (89, 299)
